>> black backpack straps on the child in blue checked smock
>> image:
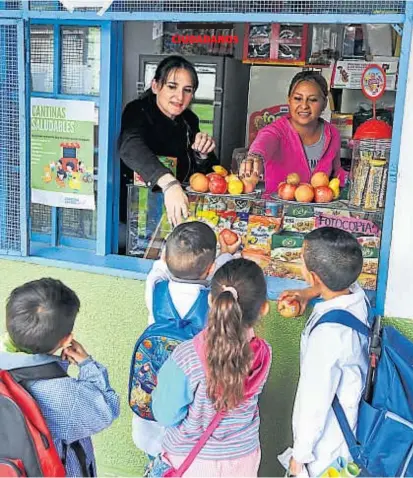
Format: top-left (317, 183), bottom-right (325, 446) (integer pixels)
top-left (8, 362), bottom-right (92, 477)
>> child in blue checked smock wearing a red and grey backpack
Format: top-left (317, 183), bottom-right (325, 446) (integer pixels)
top-left (0, 278), bottom-right (119, 476)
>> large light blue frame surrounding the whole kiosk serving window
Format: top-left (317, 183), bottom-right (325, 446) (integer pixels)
top-left (0, 0), bottom-right (413, 313)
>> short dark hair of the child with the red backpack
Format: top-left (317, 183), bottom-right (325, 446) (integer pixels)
top-left (6, 278), bottom-right (80, 354)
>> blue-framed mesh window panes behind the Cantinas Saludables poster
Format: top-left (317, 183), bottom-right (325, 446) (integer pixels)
top-left (27, 20), bottom-right (110, 252)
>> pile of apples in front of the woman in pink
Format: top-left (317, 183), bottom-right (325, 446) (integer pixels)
top-left (278, 171), bottom-right (340, 203)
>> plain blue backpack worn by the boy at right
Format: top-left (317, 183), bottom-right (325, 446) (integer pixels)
top-left (312, 310), bottom-right (413, 477)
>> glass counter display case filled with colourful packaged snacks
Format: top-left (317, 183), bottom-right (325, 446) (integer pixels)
top-left (127, 186), bottom-right (383, 291)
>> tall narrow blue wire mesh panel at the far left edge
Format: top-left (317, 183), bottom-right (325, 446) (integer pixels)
top-left (0, 24), bottom-right (21, 252)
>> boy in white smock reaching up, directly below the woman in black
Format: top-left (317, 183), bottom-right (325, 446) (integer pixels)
top-left (132, 221), bottom-right (241, 459)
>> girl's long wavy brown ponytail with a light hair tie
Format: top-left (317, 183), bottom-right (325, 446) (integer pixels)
top-left (206, 286), bottom-right (253, 410)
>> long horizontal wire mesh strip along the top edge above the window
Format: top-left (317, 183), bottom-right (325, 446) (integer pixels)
top-left (31, 0), bottom-right (406, 14)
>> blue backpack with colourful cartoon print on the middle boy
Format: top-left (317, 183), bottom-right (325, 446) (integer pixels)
top-left (129, 281), bottom-right (209, 421)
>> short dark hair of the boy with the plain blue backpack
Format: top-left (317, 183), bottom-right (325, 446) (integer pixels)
top-left (303, 227), bottom-right (363, 292)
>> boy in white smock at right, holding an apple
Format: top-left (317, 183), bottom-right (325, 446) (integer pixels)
top-left (281, 227), bottom-right (369, 476)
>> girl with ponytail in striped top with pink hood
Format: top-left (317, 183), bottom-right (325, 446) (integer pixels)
top-left (152, 259), bottom-right (271, 477)
